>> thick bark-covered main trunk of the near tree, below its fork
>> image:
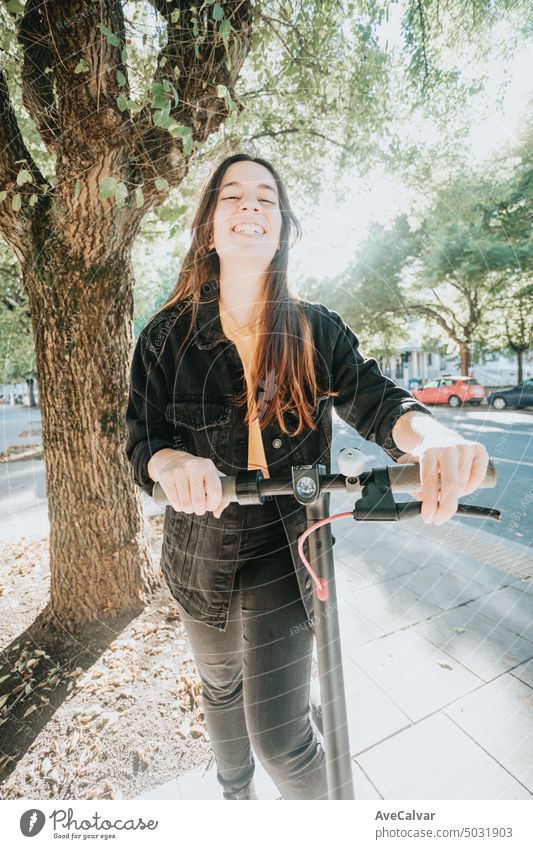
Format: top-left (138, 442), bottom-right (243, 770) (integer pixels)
top-left (25, 245), bottom-right (158, 631)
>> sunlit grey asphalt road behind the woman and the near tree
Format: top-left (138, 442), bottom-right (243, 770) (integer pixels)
top-left (0, 405), bottom-right (533, 546)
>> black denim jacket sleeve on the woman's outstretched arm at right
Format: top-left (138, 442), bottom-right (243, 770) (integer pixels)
top-left (329, 310), bottom-right (433, 460)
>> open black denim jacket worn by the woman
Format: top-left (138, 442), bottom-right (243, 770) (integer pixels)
top-left (125, 282), bottom-right (432, 631)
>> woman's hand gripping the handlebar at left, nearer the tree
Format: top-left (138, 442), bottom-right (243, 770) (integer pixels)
top-left (154, 451), bottom-right (230, 519)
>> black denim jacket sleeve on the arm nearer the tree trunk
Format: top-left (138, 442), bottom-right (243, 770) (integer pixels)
top-left (125, 328), bottom-right (183, 495)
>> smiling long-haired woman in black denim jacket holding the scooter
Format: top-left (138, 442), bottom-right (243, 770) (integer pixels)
top-left (126, 147), bottom-right (485, 799)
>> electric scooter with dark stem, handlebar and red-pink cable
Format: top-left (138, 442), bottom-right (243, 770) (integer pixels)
top-left (152, 448), bottom-right (501, 799)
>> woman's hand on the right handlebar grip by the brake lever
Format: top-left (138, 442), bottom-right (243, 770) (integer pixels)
top-left (398, 431), bottom-right (489, 525)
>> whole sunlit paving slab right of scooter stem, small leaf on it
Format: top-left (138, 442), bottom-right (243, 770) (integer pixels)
top-left (349, 629), bottom-right (483, 722)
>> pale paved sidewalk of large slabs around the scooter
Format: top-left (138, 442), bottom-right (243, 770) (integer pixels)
top-left (138, 496), bottom-right (533, 799)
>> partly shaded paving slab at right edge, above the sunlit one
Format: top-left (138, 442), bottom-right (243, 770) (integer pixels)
top-left (414, 605), bottom-right (533, 681)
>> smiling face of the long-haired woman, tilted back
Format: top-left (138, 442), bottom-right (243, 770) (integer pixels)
top-left (210, 161), bottom-right (282, 270)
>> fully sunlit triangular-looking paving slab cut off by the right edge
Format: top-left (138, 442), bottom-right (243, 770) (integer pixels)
top-left (444, 673), bottom-right (533, 792)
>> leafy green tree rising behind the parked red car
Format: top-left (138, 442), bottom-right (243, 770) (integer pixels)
top-left (404, 124), bottom-right (533, 374)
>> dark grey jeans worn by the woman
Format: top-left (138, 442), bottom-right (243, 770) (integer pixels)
top-left (172, 499), bottom-right (328, 799)
